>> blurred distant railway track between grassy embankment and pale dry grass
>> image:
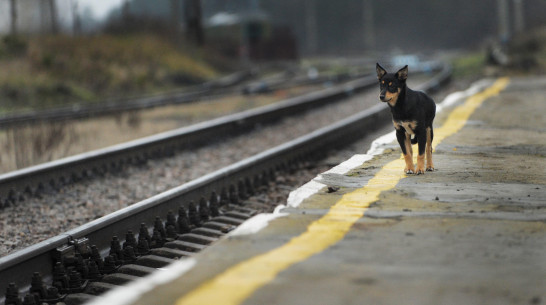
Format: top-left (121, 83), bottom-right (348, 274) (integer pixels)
top-left (0, 61), bottom-right (368, 128)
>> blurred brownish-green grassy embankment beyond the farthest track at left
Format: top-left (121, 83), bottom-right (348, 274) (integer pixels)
top-left (0, 34), bottom-right (225, 112)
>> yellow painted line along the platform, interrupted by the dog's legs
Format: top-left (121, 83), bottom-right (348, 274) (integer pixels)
top-left (176, 78), bottom-right (509, 305)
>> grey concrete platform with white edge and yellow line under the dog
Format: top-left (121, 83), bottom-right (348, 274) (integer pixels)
top-left (90, 77), bottom-right (546, 305)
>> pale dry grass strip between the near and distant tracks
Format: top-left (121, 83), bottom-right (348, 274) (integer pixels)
top-left (0, 87), bottom-right (316, 173)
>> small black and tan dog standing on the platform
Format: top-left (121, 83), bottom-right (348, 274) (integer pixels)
top-left (376, 64), bottom-right (436, 175)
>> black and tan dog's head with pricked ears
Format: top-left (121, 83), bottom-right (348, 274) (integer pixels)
top-left (375, 64), bottom-right (408, 107)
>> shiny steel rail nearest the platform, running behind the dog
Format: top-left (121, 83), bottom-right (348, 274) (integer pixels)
top-left (0, 66), bottom-right (451, 304)
